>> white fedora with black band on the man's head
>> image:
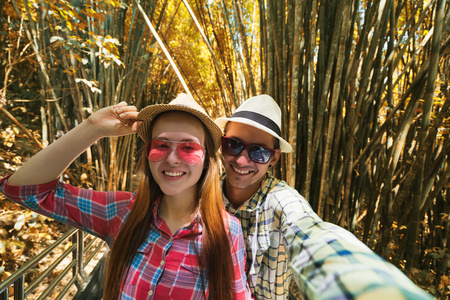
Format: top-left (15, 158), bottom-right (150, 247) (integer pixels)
top-left (215, 95), bottom-right (292, 152)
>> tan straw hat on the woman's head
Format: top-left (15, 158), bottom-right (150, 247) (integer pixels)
top-left (137, 93), bottom-right (222, 152)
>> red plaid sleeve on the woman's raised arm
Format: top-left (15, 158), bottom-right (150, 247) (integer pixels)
top-left (0, 176), bottom-right (134, 241)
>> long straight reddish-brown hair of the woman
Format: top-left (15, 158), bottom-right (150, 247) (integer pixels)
top-left (103, 114), bottom-right (235, 300)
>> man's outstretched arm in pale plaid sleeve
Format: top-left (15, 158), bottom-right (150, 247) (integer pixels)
top-left (272, 188), bottom-right (433, 299)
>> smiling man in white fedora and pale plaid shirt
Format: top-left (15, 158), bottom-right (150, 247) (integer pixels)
top-left (216, 95), bottom-right (432, 299)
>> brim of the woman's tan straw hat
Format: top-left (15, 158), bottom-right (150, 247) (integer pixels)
top-left (136, 104), bottom-right (222, 152)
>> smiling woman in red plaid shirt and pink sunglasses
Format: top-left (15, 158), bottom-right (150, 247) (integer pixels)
top-left (0, 94), bottom-right (251, 300)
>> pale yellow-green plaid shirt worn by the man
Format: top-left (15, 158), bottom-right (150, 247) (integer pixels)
top-left (222, 173), bottom-right (432, 299)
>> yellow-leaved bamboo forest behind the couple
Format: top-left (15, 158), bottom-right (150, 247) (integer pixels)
top-left (0, 0), bottom-right (450, 299)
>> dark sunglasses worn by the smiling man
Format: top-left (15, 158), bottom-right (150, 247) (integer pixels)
top-left (222, 136), bottom-right (275, 164)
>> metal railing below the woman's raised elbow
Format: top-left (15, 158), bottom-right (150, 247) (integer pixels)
top-left (0, 228), bottom-right (105, 300)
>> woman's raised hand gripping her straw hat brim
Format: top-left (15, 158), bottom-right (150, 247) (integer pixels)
top-left (87, 102), bottom-right (138, 137)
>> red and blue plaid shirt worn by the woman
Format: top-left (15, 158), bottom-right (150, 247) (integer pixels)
top-left (0, 178), bottom-right (251, 300)
